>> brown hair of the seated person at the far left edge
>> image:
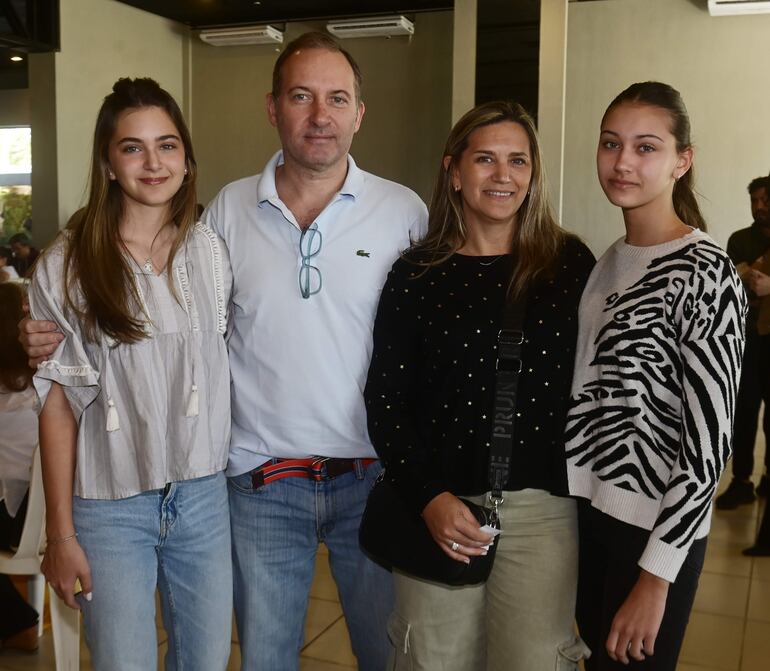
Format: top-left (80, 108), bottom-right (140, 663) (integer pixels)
top-left (0, 282), bottom-right (34, 391)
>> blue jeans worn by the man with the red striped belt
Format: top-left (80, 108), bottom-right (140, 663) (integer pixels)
top-left (229, 462), bottom-right (393, 671)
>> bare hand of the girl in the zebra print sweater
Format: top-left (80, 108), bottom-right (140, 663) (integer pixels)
top-left (607, 570), bottom-right (669, 664)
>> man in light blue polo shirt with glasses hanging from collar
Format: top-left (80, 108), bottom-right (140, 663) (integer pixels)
top-left (204, 33), bottom-right (427, 671)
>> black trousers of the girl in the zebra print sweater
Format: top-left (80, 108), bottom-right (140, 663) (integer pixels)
top-left (577, 500), bottom-right (706, 671)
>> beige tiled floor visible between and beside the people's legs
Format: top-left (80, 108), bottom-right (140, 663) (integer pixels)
top-left (0, 460), bottom-right (770, 671)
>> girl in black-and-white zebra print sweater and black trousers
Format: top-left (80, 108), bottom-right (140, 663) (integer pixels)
top-left (567, 82), bottom-right (746, 671)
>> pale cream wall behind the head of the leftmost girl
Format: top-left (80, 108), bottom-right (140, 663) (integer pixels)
top-left (30, 0), bottom-right (188, 244)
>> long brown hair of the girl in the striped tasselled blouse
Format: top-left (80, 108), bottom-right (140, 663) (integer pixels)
top-left (64, 78), bottom-right (197, 343)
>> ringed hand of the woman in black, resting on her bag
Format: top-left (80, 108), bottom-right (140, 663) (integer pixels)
top-left (422, 492), bottom-right (494, 564)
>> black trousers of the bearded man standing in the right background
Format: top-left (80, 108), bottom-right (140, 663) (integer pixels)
top-left (733, 322), bottom-right (770, 480)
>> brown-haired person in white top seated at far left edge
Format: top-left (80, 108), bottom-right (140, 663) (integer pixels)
top-left (0, 282), bottom-right (38, 651)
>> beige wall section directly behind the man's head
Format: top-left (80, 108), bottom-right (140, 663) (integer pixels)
top-left (192, 12), bottom-right (452, 203)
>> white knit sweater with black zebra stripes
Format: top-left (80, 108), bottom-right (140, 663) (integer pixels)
top-left (566, 230), bottom-right (746, 582)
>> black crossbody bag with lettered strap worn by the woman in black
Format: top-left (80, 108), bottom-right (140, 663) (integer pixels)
top-left (358, 297), bottom-right (526, 585)
